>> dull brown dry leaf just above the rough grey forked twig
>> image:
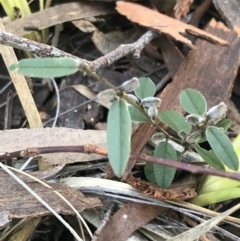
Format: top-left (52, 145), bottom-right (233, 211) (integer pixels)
top-left (92, 29), bottom-right (140, 54)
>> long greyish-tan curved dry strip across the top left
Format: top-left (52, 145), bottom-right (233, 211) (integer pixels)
top-left (5, 1), bottom-right (114, 36)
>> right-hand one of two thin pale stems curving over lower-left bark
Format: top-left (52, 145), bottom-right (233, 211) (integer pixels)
top-left (6, 163), bottom-right (93, 237)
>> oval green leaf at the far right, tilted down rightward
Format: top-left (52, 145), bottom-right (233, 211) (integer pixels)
top-left (206, 126), bottom-right (239, 171)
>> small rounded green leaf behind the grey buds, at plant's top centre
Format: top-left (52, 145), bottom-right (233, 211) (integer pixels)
top-left (134, 77), bottom-right (156, 99)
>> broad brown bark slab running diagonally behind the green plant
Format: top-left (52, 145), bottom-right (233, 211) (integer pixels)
top-left (124, 21), bottom-right (240, 178)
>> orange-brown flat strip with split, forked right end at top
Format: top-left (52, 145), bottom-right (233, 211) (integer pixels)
top-left (116, 1), bottom-right (229, 49)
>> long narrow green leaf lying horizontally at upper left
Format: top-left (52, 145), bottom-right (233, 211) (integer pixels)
top-left (9, 58), bottom-right (78, 78)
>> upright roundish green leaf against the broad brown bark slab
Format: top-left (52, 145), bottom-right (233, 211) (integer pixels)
top-left (179, 88), bottom-right (207, 115)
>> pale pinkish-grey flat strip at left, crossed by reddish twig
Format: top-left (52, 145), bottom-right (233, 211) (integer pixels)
top-left (0, 128), bottom-right (107, 165)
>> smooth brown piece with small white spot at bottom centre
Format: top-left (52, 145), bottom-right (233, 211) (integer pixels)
top-left (94, 202), bottom-right (168, 241)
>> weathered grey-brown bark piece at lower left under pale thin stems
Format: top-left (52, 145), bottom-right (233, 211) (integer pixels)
top-left (0, 171), bottom-right (101, 218)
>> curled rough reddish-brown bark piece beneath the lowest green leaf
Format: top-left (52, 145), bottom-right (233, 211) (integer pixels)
top-left (126, 175), bottom-right (197, 200)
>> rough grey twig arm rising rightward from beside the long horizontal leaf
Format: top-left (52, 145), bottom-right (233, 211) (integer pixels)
top-left (89, 30), bottom-right (158, 71)
